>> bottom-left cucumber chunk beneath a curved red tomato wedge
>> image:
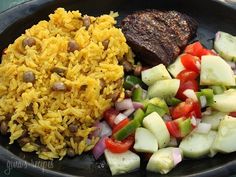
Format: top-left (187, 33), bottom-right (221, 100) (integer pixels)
top-left (105, 149), bottom-right (140, 175)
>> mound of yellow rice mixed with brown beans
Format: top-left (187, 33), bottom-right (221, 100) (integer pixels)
top-left (0, 8), bottom-right (132, 160)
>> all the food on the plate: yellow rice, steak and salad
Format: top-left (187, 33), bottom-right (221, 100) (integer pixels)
top-left (0, 5), bottom-right (236, 175)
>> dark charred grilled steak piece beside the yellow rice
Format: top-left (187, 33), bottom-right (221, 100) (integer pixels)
top-left (121, 10), bottom-right (197, 65)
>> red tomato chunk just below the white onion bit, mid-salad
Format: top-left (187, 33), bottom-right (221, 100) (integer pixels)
top-left (171, 98), bottom-right (193, 119)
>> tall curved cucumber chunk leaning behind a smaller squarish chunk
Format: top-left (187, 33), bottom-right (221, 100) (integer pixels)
top-left (143, 112), bottom-right (170, 148)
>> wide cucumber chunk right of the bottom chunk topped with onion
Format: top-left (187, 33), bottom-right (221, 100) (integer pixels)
top-left (179, 130), bottom-right (217, 158)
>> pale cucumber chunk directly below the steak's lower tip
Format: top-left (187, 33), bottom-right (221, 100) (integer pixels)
top-left (141, 64), bottom-right (171, 86)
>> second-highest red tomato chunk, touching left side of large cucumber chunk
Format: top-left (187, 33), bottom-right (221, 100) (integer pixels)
top-left (181, 54), bottom-right (201, 73)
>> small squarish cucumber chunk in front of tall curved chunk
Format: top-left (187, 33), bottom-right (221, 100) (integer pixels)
top-left (134, 127), bottom-right (158, 153)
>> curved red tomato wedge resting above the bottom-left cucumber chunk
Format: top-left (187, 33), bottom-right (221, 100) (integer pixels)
top-left (105, 135), bottom-right (134, 153)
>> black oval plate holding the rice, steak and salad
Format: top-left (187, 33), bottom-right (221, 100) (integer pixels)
top-left (0, 0), bottom-right (236, 177)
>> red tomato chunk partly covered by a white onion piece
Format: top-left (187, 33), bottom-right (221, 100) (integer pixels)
top-left (176, 80), bottom-right (198, 101)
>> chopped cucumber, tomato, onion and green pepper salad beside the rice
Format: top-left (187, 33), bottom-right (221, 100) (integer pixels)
top-left (93, 32), bottom-right (236, 175)
